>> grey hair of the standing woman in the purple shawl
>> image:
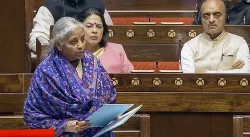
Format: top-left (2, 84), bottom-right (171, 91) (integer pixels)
top-left (42, 17), bottom-right (83, 58)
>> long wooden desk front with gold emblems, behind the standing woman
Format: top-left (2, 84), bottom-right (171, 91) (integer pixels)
top-left (0, 74), bottom-right (250, 137)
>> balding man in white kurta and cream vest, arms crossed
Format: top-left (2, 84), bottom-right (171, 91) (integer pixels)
top-left (181, 0), bottom-right (250, 73)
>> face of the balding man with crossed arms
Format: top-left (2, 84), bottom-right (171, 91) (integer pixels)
top-left (201, 0), bottom-right (226, 39)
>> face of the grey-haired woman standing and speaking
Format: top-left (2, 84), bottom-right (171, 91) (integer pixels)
top-left (57, 26), bottom-right (86, 61)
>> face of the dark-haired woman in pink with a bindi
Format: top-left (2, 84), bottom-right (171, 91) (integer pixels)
top-left (83, 14), bottom-right (103, 46)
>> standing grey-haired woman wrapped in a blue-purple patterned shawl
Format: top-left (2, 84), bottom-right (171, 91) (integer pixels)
top-left (24, 17), bottom-right (116, 137)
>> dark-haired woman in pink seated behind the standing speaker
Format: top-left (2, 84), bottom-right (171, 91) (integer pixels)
top-left (78, 8), bottom-right (134, 73)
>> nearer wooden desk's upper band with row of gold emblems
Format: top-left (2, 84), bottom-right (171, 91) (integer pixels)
top-left (5, 73), bottom-right (250, 93)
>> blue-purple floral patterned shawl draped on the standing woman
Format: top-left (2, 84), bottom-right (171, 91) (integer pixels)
top-left (24, 49), bottom-right (116, 137)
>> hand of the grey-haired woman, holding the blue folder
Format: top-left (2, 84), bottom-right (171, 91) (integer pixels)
top-left (65, 120), bottom-right (91, 133)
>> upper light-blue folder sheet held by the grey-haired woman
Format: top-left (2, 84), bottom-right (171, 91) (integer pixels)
top-left (86, 104), bottom-right (134, 127)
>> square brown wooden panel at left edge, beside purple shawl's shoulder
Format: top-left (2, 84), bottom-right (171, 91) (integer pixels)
top-left (0, 74), bottom-right (23, 93)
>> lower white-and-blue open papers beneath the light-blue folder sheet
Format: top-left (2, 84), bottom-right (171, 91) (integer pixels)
top-left (93, 105), bottom-right (142, 137)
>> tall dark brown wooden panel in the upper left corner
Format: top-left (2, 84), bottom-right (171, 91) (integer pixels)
top-left (0, 0), bottom-right (30, 73)
